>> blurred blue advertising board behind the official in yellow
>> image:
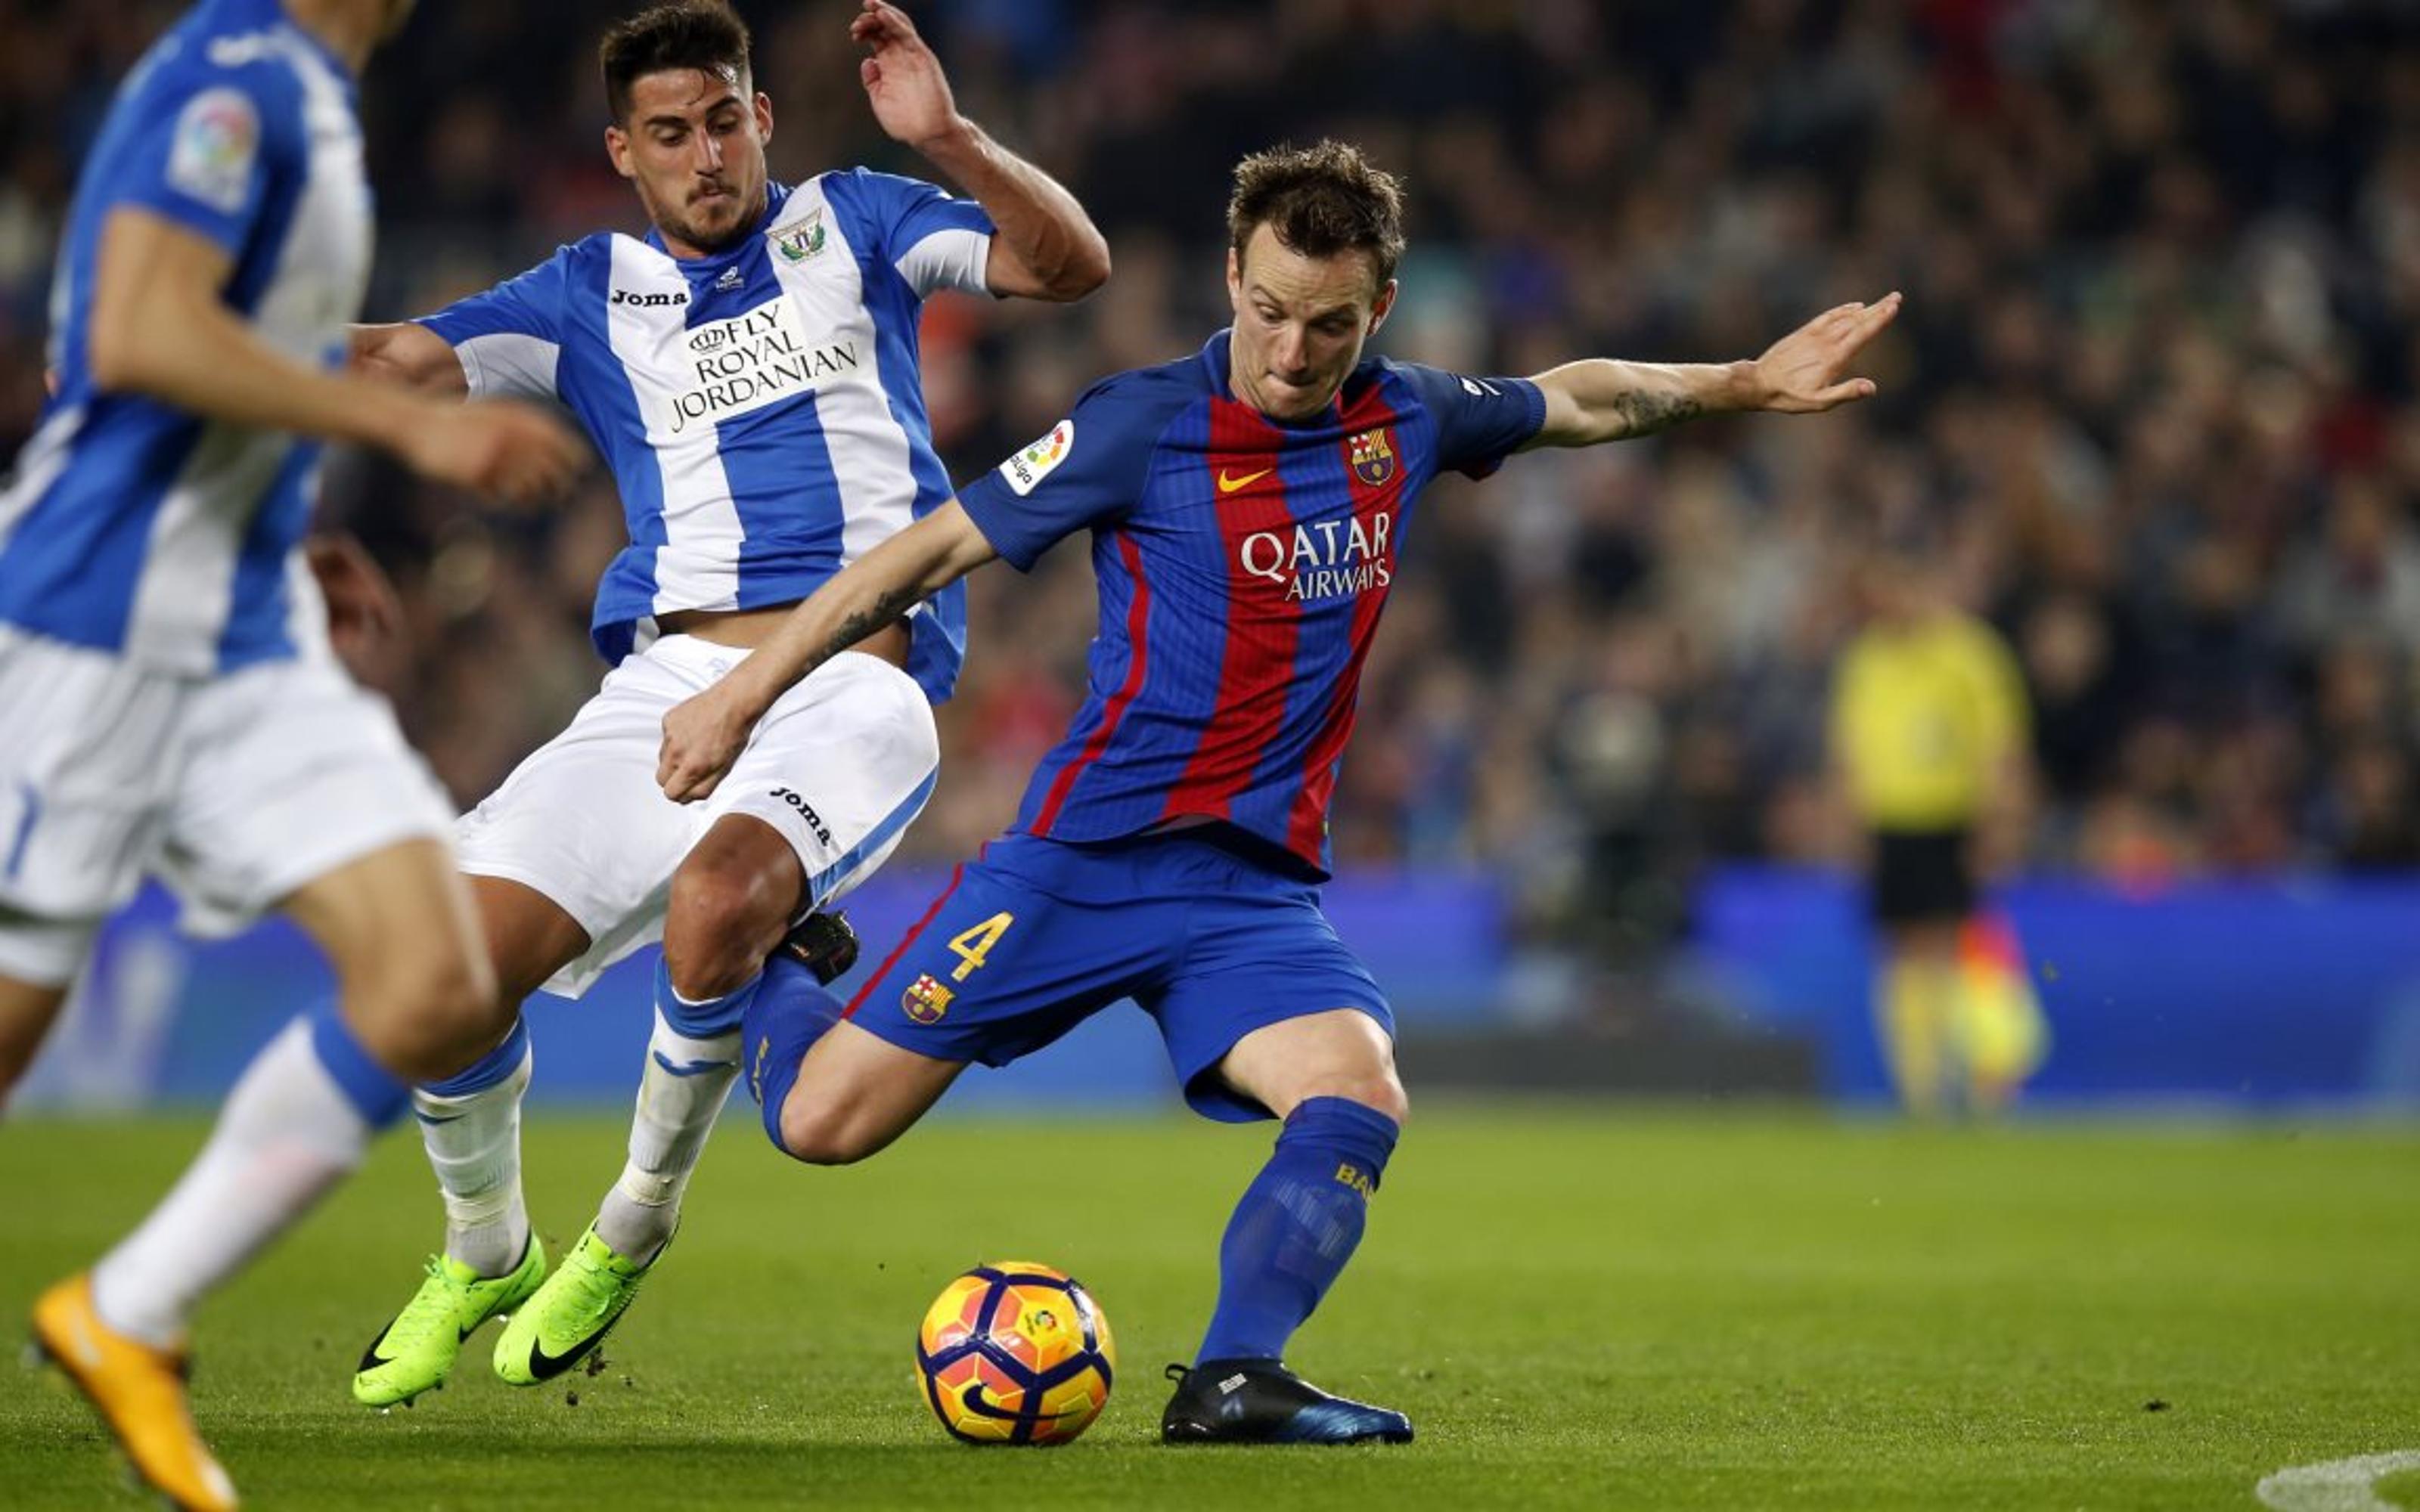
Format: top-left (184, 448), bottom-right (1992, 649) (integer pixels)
top-left (1696, 869), bottom-right (2420, 1108)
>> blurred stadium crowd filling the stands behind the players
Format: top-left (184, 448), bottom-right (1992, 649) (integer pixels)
top-left (0, 0), bottom-right (2420, 958)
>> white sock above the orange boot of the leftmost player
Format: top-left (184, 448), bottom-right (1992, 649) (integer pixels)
top-left (92, 1018), bottom-right (373, 1347)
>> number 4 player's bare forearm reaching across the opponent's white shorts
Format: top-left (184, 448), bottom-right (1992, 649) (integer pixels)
top-left (656, 498), bottom-right (997, 803)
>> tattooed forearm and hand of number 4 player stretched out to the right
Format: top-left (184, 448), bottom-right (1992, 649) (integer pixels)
top-left (1525, 293), bottom-right (1900, 450)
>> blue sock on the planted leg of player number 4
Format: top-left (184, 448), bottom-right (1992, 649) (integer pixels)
top-left (1193, 1098), bottom-right (1401, 1365)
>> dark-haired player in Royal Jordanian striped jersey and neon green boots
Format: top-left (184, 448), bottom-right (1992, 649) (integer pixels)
top-left (353, 0), bottom-right (1109, 1405)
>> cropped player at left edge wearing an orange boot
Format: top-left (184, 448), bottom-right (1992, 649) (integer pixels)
top-left (0, 0), bottom-right (583, 1507)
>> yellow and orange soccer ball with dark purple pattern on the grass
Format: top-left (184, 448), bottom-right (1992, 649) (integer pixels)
top-left (915, 1260), bottom-right (1118, 1444)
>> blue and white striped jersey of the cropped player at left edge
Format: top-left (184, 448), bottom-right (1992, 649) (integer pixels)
top-left (0, 0), bottom-right (371, 675)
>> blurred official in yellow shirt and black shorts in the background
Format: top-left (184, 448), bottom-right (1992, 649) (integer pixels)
top-left (1832, 547), bottom-right (2047, 1117)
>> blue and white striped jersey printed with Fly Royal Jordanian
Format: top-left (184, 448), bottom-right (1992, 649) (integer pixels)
top-left (421, 169), bottom-right (992, 702)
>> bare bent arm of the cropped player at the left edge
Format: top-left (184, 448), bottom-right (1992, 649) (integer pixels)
top-left (89, 206), bottom-right (583, 500)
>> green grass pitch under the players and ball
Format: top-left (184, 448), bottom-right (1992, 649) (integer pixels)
top-left (0, 1103), bottom-right (2420, 1512)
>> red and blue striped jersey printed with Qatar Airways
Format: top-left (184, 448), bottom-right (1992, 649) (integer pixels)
top-left (958, 331), bottom-right (1547, 875)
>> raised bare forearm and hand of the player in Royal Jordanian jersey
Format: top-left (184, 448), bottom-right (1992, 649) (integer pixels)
top-left (849, 0), bottom-right (1109, 300)
